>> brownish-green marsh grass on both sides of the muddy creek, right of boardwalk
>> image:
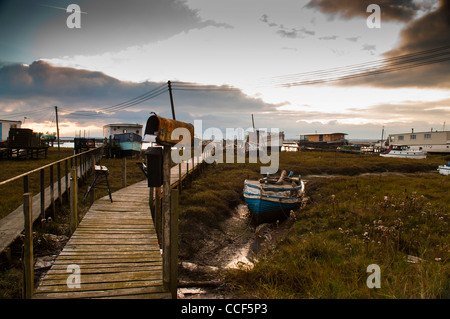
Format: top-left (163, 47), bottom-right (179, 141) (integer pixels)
top-left (180, 152), bottom-right (450, 298)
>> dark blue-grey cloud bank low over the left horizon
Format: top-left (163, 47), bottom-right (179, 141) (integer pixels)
top-left (0, 61), bottom-right (277, 131)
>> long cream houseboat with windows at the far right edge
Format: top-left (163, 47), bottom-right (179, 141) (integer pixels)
top-left (386, 130), bottom-right (450, 153)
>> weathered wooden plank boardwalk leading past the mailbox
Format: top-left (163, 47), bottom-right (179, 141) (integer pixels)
top-left (33, 158), bottom-right (203, 299)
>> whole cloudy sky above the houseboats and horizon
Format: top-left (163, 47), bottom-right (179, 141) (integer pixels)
top-left (0, 0), bottom-right (450, 139)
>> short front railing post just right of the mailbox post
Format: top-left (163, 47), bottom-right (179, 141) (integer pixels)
top-left (170, 189), bottom-right (179, 299)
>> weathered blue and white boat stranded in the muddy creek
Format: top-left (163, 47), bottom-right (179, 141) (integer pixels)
top-left (244, 171), bottom-right (305, 223)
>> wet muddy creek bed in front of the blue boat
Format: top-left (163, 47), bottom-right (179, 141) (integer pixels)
top-left (178, 203), bottom-right (295, 299)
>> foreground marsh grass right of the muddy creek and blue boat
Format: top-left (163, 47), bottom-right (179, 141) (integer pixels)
top-left (228, 175), bottom-right (450, 298)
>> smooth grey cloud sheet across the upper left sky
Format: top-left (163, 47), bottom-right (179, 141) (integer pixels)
top-left (7, 0), bottom-right (231, 60)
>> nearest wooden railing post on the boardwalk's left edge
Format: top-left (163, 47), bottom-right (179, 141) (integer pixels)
top-left (23, 193), bottom-right (34, 299)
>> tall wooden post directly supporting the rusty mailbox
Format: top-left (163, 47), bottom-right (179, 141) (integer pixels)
top-left (162, 146), bottom-right (171, 289)
